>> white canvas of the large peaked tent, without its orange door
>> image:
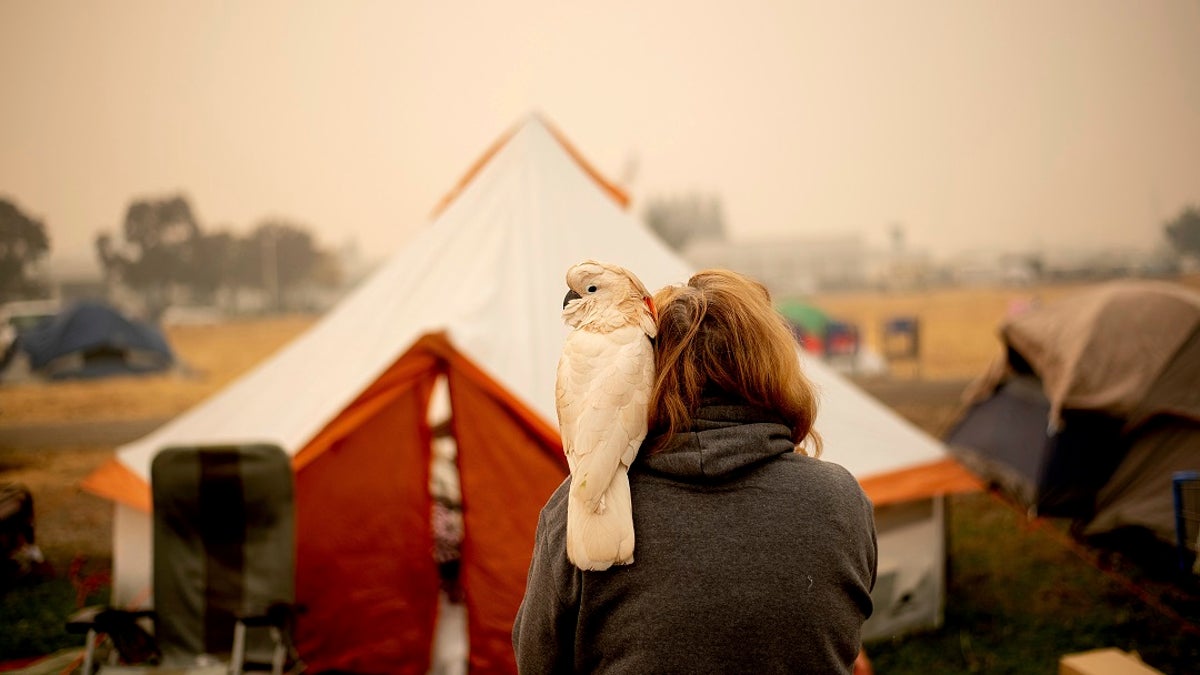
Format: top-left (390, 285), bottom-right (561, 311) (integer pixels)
top-left (85, 117), bottom-right (979, 662)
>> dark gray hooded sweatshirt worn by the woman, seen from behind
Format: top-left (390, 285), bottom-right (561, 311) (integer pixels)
top-left (512, 401), bottom-right (876, 674)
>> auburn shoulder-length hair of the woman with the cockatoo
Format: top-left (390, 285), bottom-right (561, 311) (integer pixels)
top-left (649, 269), bottom-right (821, 455)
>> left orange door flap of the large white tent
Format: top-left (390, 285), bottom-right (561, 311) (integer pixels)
top-left (296, 357), bottom-right (438, 674)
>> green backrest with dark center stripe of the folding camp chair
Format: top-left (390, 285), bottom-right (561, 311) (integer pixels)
top-left (150, 444), bottom-right (295, 665)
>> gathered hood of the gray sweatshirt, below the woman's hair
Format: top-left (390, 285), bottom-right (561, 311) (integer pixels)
top-left (632, 401), bottom-right (796, 479)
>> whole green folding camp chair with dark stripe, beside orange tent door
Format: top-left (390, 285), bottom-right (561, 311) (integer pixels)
top-left (67, 444), bottom-right (302, 675)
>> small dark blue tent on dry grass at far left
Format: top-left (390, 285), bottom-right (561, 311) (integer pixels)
top-left (17, 300), bottom-right (175, 378)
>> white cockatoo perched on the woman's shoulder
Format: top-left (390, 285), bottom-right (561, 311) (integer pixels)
top-left (556, 261), bottom-right (658, 571)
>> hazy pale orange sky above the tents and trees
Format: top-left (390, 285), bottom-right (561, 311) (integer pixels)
top-left (0, 0), bottom-right (1200, 270)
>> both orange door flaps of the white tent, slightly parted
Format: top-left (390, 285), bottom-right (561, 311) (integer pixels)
top-left (295, 335), bottom-right (566, 674)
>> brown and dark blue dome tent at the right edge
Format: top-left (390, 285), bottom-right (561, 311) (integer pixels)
top-left (948, 281), bottom-right (1200, 543)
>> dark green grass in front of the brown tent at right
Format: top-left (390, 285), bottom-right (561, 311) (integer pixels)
top-left (866, 492), bottom-right (1200, 675)
